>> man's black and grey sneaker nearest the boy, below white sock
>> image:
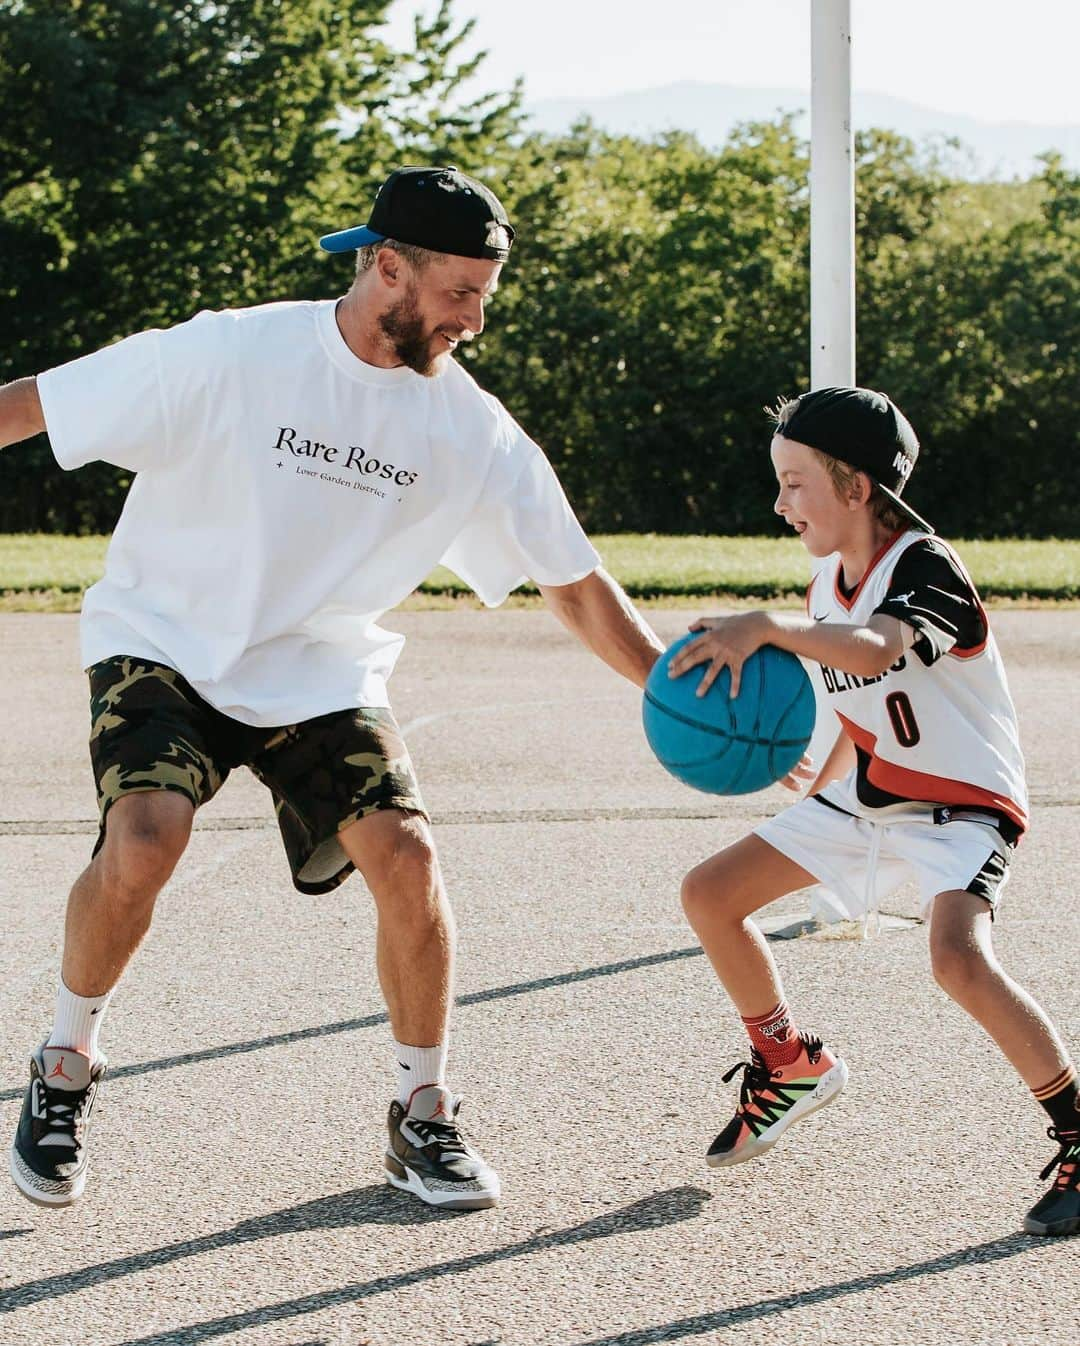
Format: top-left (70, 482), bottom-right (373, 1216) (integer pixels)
top-left (385, 1085), bottom-right (500, 1210)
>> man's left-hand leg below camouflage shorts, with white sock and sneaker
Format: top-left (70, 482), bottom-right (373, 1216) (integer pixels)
top-left (11, 790), bottom-right (194, 1206)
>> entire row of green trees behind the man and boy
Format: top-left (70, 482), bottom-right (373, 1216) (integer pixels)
top-left (0, 0), bottom-right (1080, 536)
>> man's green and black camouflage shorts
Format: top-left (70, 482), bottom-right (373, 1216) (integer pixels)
top-left (88, 656), bottom-right (427, 892)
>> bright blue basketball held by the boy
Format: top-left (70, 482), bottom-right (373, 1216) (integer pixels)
top-left (642, 633), bottom-right (815, 794)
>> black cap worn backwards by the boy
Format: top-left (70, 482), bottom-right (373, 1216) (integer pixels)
top-left (776, 388), bottom-right (933, 533)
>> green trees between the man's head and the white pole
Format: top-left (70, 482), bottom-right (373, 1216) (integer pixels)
top-left (466, 121), bottom-right (807, 532)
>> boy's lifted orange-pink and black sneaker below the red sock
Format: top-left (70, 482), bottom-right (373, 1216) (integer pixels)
top-left (706, 1032), bottom-right (847, 1168)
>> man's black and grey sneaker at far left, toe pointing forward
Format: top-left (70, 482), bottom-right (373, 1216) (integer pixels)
top-left (11, 1046), bottom-right (106, 1206)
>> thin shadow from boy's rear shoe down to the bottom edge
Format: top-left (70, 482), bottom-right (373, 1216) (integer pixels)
top-left (579, 1234), bottom-right (1053, 1346)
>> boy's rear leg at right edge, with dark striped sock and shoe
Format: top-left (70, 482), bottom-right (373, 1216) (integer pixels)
top-left (931, 891), bottom-right (1080, 1234)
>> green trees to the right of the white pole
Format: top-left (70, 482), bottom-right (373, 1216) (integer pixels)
top-left (859, 145), bottom-right (1080, 537)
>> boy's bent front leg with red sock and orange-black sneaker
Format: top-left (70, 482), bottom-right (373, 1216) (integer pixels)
top-left (683, 835), bottom-right (847, 1168)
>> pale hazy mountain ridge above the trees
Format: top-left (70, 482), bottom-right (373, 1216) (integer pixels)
top-left (527, 83), bottom-right (1080, 178)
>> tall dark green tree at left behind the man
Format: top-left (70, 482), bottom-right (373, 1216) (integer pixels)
top-left (0, 0), bottom-right (516, 532)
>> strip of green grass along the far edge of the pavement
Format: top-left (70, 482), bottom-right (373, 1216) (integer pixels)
top-left (0, 533), bottom-right (1080, 611)
